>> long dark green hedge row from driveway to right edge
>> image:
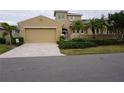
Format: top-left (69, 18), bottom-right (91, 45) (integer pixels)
top-left (57, 38), bottom-right (124, 49)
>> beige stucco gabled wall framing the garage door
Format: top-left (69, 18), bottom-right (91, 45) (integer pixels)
top-left (18, 16), bottom-right (62, 41)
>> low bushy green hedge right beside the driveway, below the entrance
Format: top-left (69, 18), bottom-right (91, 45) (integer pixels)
top-left (59, 41), bottom-right (97, 49)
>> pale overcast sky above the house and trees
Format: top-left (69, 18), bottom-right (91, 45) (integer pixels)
top-left (0, 10), bottom-right (119, 25)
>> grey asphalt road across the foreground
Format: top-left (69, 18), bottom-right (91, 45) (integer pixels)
top-left (0, 53), bottom-right (124, 82)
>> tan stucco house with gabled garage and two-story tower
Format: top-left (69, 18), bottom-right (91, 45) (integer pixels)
top-left (18, 11), bottom-right (82, 43)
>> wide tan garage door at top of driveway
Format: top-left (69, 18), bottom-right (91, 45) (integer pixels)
top-left (26, 28), bottom-right (56, 43)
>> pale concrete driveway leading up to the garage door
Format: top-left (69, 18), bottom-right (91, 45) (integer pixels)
top-left (0, 43), bottom-right (63, 58)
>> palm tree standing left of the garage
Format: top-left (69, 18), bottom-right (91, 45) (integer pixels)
top-left (1, 23), bottom-right (17, 44)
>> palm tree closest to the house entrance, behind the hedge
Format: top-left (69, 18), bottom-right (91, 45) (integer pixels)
top-left (71, 20), bottom-right (83, 38)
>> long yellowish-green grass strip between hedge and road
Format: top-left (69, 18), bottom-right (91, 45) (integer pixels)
top-left (61, 45), bottom-right (124, 55)
